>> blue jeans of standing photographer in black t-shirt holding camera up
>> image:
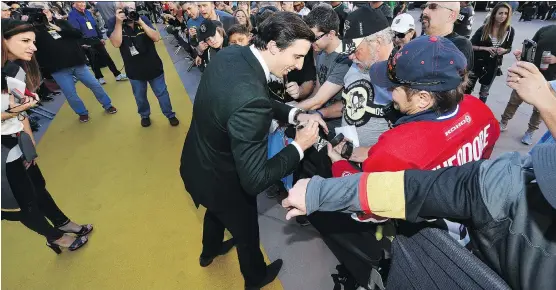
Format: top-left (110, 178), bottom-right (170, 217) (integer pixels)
top-left (129, 74), bottom-right (176, 119)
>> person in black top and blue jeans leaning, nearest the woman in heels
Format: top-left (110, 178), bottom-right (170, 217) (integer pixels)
top-left (30, 7), bottom-right (117, 123)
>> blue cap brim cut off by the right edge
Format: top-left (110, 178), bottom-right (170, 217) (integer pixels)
top-left (531, 144), bottom-right (556, 208)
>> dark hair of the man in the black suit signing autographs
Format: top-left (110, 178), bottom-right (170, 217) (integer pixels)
top-left (253, 12), bottom-right (315, 50)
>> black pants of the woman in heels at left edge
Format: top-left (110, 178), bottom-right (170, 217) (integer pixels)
top-left (2, 159), bottom-right (69, 241)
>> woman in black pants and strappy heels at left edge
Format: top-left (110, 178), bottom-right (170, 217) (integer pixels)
top-left (1, 19), bottom-right (93, 254)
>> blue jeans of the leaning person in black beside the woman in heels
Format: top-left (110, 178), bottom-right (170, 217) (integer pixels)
top-left (52, 65), bottom-right (112, 116)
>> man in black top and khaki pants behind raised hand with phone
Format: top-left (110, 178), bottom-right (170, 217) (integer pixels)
top-left (500, 25), bottom-right (556, 145)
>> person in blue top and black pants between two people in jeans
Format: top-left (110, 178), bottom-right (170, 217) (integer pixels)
top-left (68, 2), bottom-right (127, 85)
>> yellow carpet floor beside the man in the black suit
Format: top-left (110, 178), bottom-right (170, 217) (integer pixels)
top-left (1, 36), bottom-right (282, 290)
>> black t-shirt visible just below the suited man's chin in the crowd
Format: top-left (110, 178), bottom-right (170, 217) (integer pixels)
top-left (268, 49), bottom-right (317, 103)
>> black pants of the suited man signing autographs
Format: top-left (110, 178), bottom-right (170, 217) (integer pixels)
top-left (201, 197), bottom-right (266, 286)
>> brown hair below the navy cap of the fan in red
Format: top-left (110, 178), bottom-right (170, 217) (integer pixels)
top-left (402, 71), bottom-right (469, 114)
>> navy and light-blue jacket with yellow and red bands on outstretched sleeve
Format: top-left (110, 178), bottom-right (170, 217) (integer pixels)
top-left (306, 152), bottom-right (556, 290)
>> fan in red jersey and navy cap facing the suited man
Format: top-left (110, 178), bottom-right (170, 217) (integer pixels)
top-left (329, 36), bottom-right (500, 219)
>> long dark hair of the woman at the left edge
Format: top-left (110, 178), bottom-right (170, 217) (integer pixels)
top-left (2, 19), bottom-right (42, 92)
